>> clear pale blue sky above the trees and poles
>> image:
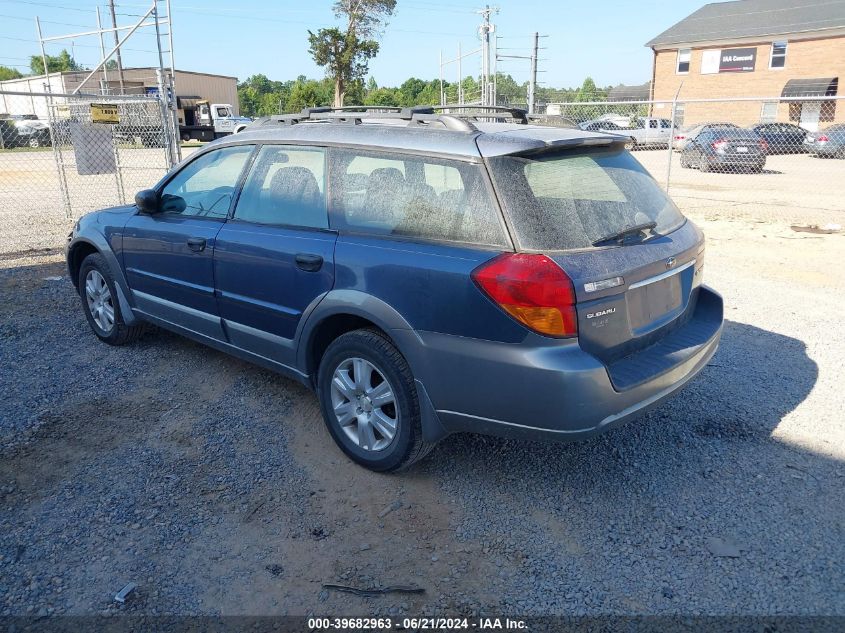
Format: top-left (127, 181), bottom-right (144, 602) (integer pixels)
top-left (0, 0), bottom-right (704, 88)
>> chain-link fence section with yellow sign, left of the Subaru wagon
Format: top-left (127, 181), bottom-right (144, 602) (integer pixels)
top-left (0, 92), bottom-right (175, 255)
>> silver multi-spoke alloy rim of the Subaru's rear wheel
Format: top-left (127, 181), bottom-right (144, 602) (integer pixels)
top-left (331, 358), bottom-right (399, 451)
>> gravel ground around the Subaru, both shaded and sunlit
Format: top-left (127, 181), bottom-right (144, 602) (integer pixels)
top-left (0, 217), bottom-right (845, 615)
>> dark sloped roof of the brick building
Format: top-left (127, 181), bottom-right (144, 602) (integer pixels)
top-left (646, 0), bottom-right (845, 48)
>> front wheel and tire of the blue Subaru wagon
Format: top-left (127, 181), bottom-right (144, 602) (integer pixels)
top-left (77, 253), bottom-right (144, 345)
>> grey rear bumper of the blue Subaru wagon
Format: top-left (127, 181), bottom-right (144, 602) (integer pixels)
top-left (400, 287), bottom-right (722, 441)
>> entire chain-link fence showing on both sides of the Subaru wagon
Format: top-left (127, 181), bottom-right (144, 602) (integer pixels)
top-left (0, 92), bottom-right (845, 254)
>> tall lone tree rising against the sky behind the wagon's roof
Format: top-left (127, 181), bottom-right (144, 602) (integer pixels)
top-left (308, 0), bottom-right (396, 107)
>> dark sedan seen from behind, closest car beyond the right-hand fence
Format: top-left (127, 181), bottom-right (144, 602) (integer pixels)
top-left (681, 128), bottom-right (766, 173)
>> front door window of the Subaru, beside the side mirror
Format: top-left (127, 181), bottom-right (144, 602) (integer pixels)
top-left (161, 145), bottom-right (253, 218)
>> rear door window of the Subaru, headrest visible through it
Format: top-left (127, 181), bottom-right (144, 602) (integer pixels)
top-left (235, 145), bottom-right (329, 229)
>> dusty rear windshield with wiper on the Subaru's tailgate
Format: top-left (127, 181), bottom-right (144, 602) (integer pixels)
top-left (490, 148), bottom-right (684, 251)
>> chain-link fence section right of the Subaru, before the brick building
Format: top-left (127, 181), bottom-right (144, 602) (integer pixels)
top-left (546, 96), bottom-right (845, 226)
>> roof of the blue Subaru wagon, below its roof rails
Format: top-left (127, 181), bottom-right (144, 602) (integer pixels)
top-left (215, 112), bottom-right (619, 158)
